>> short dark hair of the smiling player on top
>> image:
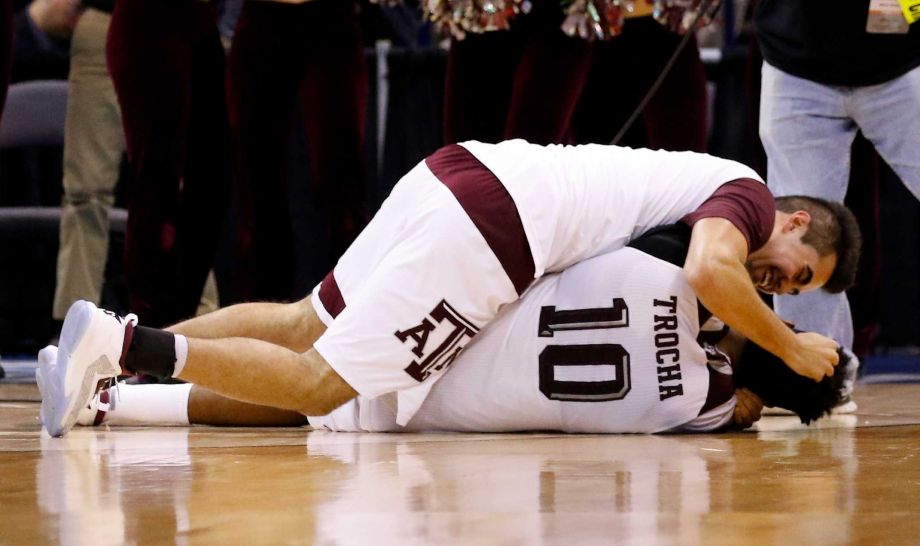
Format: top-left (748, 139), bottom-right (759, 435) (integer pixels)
top-left (776, 195), bottom-right (862, 293)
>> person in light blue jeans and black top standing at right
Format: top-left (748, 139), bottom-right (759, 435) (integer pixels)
top-left (754, 0), bottom-right (920, 408)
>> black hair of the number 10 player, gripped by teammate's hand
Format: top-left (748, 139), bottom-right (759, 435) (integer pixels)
top-left (733, 341), bottom-right (849, 425)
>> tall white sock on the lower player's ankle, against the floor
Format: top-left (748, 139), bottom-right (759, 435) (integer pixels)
top-left (102, 383), bottom-right (192, 426)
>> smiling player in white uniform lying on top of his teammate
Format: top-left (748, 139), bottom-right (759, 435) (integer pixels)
top-left (36, 140), bottom-right (859, 436)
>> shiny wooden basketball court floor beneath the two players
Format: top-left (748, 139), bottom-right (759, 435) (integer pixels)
top-left (0, 384), bottom-right (920, 546)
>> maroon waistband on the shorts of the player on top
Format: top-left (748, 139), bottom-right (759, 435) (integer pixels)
top-left (425, 144), bottom-right (534, 295)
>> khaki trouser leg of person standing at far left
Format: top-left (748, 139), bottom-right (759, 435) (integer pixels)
top-left (53, 8), bottom-right (124, 320)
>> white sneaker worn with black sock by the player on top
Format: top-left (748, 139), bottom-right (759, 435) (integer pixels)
top-left (35, 300), bottom-right (137, 437)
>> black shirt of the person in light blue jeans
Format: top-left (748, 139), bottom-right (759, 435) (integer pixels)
top-left (754, 0), bottom-right (920, 86)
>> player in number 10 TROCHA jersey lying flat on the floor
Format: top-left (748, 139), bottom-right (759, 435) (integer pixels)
top-left (39, 225), bottom-right (844, 433)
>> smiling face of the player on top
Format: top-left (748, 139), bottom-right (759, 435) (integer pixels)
top-left (746, 230), bottom-right (837, 294)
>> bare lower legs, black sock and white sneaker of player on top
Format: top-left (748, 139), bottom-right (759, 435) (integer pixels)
top-left (40, 301), bottom-right (357, 436)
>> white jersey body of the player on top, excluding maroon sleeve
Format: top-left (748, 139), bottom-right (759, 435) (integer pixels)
top-left (461, 140), bottom-right (763, 277)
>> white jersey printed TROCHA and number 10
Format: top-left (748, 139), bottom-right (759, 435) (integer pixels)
top-left (311, 248), bottom-right (731, 433)
